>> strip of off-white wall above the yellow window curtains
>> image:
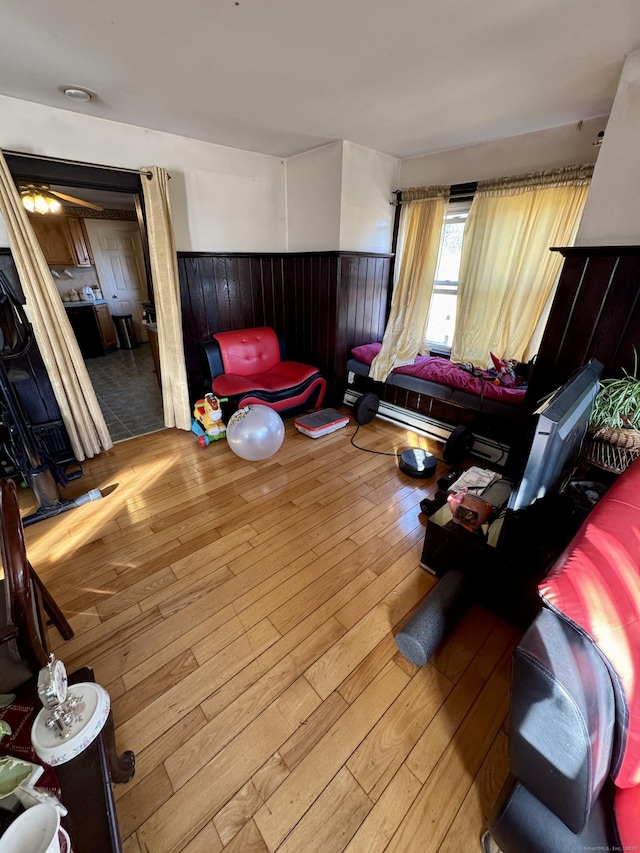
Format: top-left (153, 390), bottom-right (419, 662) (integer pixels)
top-left (399, 116), bottom-right (608, 187)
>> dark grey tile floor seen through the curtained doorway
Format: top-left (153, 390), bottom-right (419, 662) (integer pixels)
top-left (85, 343), bottom-right (164, 441)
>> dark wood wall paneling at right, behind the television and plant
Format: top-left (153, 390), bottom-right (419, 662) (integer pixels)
top-left (526, 246), bottom-right (640, 408)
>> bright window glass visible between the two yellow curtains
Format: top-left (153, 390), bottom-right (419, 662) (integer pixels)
top-left (425, 198), bottom-right (471, 350)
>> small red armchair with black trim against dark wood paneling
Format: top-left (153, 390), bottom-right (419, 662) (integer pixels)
top-left (203, 326), bottom-right (326, 414)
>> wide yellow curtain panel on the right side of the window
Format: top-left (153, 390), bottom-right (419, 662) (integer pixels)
top-left (451, 166), bottom-right (593, 366)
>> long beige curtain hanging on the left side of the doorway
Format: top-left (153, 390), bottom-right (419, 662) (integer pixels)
top-left (0, 151), bottom-right (113, 462)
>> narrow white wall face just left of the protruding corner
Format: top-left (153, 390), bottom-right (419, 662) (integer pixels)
top-left (286, 142), bottom-right (343, 252)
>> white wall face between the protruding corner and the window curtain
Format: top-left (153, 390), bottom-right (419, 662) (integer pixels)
top-left (340, 142), bottom-right (400, 252)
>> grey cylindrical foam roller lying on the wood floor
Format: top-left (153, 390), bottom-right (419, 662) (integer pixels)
top-left (396, 569), bottom-right (470, 666)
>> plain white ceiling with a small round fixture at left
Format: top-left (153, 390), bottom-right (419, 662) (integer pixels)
top-left (0, 0), bottom-right (640, 158)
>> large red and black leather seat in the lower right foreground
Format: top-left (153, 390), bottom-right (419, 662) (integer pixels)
top-left (484, 461), bottom-right (640, 853)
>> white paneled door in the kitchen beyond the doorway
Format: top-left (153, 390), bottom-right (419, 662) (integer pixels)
top-left (84, 219), bottom-right (147, 341)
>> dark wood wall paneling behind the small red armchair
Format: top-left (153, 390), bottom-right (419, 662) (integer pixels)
top-left (178, 252), bottom-right (391, 405)
